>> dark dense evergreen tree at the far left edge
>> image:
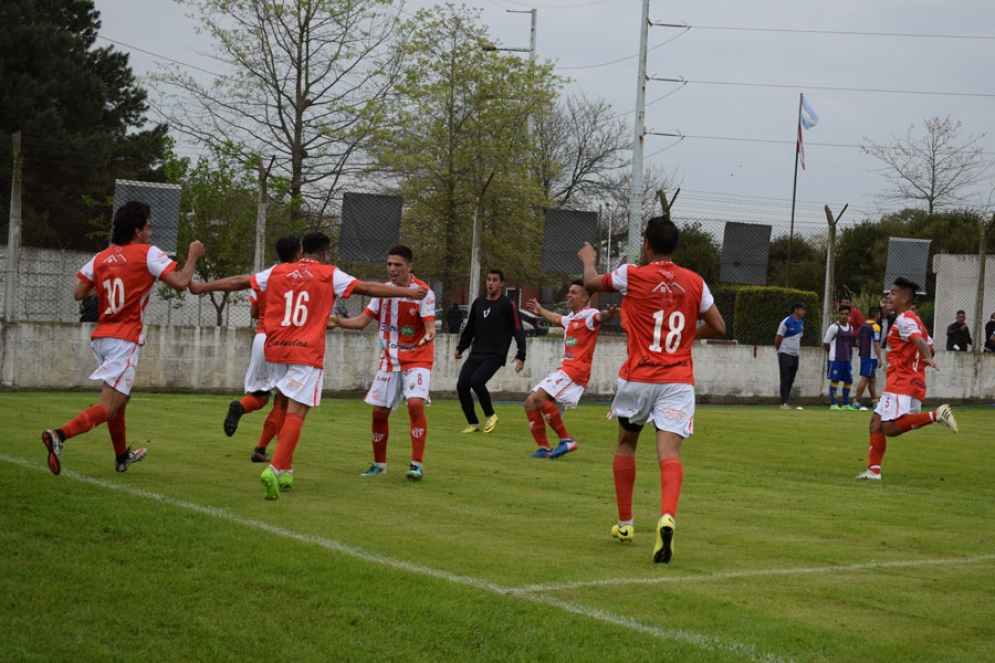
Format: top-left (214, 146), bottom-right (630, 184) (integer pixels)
top-left (0, 0), bottom-right (166, 250)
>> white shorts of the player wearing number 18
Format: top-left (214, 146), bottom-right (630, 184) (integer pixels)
top-left (609, 378), bottom-right (694, 438)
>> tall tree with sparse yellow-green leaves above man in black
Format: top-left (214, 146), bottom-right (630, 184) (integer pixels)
top-left (369, 5), bottom-right (558, 301)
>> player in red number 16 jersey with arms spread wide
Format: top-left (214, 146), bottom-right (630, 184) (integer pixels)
top-left (191, 232), bottom-right (428, 500)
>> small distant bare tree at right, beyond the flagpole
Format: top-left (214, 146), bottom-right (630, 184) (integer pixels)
top-left (860, 116), bottom-right (992, 214)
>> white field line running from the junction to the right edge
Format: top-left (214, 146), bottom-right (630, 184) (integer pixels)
top-left (512, 555), bottom-right (995, 592)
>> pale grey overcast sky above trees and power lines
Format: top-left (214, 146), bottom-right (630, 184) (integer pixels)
top-left (95, 0), bottom-right (995, 234)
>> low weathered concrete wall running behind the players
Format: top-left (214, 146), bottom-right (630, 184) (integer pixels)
top-left (0, 322), bottom-right (995, 404)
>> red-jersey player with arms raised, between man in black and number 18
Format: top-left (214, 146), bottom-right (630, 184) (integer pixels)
top-left (525, 279), bottom-right (618, 458)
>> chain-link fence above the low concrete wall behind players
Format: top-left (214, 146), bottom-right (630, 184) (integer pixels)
top-left (0, 136), bottom-right (995, 349)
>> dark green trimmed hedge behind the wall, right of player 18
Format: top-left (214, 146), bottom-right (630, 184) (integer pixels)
top-left (726, 286), bottom-right (822, 347)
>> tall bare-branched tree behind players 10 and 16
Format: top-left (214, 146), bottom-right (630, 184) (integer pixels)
top-left (155, 0), bottom-right (398, 216)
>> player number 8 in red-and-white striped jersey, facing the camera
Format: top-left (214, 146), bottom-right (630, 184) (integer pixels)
top-left (329, 246), bottom-right (435, 481)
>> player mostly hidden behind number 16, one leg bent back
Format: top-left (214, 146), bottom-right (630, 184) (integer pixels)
top-left (190, 235), bottom-right (301, 463)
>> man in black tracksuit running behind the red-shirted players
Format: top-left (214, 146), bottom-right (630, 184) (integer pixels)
top-left (453, 269), bottom-right (525, 433)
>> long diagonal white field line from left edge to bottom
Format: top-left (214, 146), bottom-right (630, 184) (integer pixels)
top-left (0, 454), bottom-right (790, 663)
